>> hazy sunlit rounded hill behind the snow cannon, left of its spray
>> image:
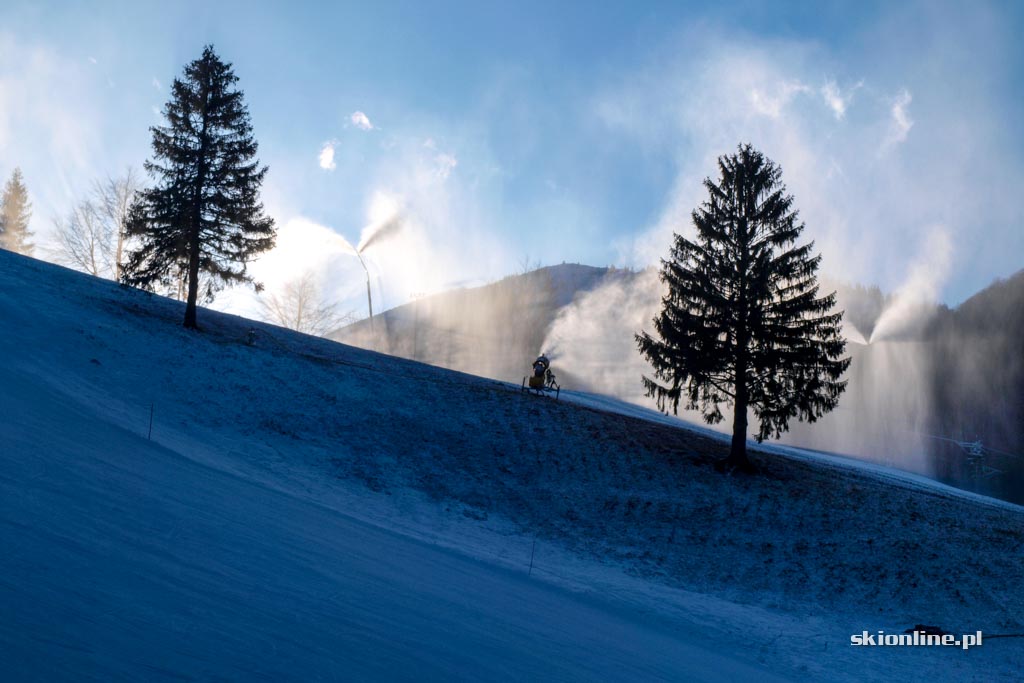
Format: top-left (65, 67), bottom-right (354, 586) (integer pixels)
top-left (329, 263), bottom-right (633, 382)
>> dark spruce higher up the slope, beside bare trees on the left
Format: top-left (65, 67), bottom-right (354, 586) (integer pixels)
top-left (122, 46), bottom-right (274, 329)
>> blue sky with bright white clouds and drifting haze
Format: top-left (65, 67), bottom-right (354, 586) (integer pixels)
top-left (0, 1), bottom-right (1024, 316)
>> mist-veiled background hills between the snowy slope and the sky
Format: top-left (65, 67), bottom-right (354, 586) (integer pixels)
top-left (332, 264), bottom-right (1024, 502)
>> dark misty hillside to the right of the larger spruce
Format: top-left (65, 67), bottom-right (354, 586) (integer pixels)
top-left (806, 270), bottom-right (1024, 503)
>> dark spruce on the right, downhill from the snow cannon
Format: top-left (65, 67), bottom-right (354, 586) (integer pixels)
top-left (636, 144), bottom-right (850, 468)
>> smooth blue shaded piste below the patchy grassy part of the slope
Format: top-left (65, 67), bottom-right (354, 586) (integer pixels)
top-left (0, 369), bottom-right (779, 681)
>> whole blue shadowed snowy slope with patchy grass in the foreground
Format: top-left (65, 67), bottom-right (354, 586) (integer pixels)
top-left (0, 252), bottom-right (1024, 681)
